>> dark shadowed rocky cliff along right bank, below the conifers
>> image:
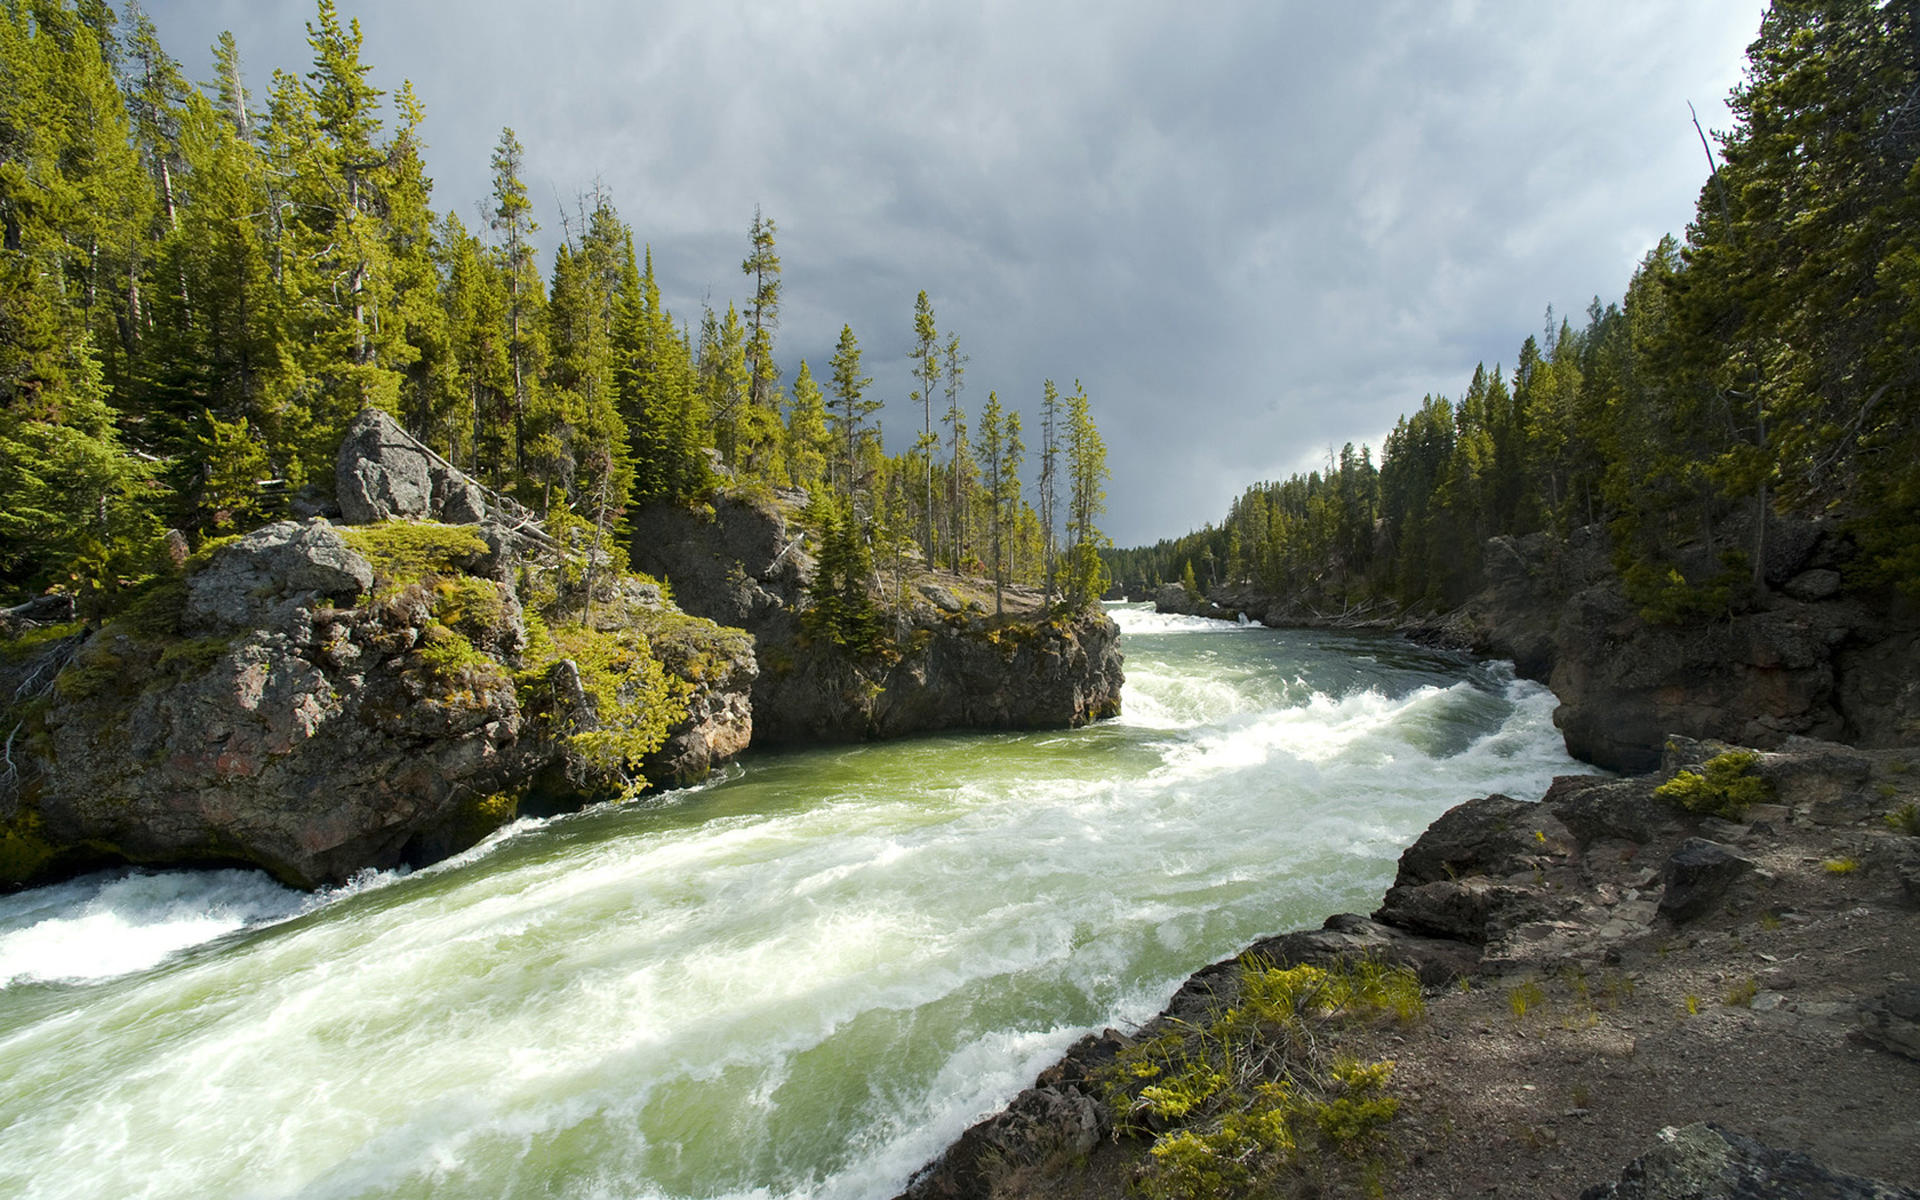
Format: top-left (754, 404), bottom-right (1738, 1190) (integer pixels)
top-left (1156, 520), bottom-right (1920, 770)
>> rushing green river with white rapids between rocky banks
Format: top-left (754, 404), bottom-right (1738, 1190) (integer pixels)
top-left (0, 607), bottom-right (1578, 1200)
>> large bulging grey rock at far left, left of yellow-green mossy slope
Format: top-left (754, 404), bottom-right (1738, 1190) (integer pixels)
top-left (18, 520), bottom-right (524, 887)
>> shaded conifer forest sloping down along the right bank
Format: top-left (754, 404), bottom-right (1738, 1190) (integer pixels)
top-left (1106, 0), bottom-right (1920, 622)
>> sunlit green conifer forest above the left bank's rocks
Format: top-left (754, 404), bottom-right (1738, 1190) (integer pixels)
top-left (0, 0), bottom-right (1108, 637)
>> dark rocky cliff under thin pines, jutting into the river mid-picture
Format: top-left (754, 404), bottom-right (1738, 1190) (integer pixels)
top-left (632, 493), bottom-right (1123, 743)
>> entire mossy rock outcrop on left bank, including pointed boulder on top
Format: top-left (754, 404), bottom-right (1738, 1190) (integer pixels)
top-left (0, 413), bottom-right (756, 887)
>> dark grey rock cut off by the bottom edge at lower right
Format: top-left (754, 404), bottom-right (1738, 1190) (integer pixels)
top-left (1580, 1121), bottom-right (1920, 1200)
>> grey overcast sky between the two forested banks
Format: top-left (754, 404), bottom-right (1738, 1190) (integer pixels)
top-left (148, 0), bottom-right (1764, 545)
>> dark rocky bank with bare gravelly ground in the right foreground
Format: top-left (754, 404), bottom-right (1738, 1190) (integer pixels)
top-left (904, 739), bottom-right (1920, 1200)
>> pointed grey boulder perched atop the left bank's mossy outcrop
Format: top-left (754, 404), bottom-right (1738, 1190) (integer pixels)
top-left (334, 409), bottom-right (488, 524)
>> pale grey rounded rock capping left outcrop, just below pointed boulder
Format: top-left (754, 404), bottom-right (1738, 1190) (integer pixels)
top-left (180, 516), bottom-right (372, 634)
